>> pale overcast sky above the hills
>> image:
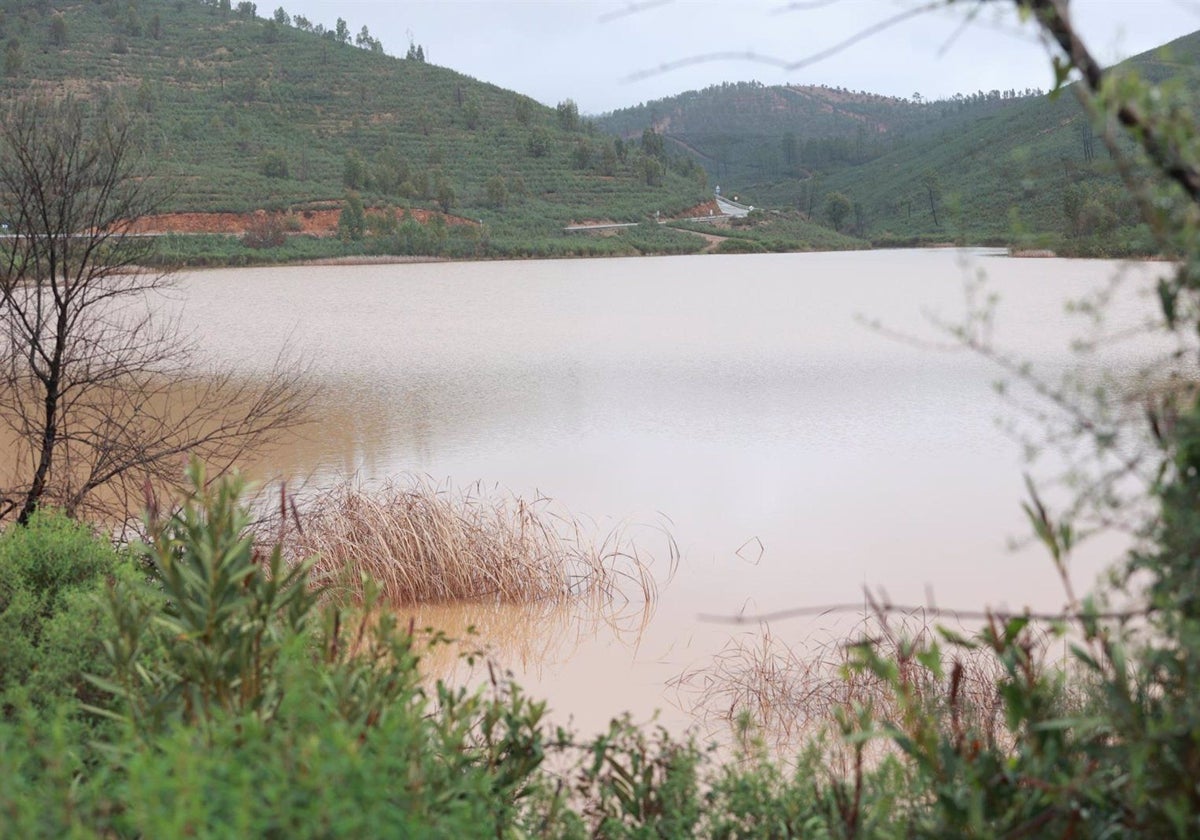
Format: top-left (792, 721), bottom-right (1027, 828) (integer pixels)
top-left (276, 0), bottom-right (1200, 114)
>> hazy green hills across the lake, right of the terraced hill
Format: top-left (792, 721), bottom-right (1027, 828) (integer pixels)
top-left (599, 34), bottom-right (1200, 254)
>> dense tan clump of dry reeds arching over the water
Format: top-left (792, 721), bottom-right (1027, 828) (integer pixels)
top-left (274, 479), bottom-right (676, 605)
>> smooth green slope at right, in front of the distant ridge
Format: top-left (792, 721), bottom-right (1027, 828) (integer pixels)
top-left (801, 34), bottom-right (1200, 254)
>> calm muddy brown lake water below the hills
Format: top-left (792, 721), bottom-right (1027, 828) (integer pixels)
top-left (179, 250), bottom-right (1165, 731)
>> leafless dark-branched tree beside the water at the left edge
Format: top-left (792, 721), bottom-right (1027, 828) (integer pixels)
top-left (0, 98), bottom-right (305, 523)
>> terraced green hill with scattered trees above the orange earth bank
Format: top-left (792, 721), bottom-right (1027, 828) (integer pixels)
top-left (0, 0), bottom-right (708, 258)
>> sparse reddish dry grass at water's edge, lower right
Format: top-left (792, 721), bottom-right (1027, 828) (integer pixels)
top-left (671, 616), bottom-right (1003, 763)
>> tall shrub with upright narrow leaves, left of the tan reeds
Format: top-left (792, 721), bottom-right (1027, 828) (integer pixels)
top-left (94, 462), bottom-right (314, 738)
